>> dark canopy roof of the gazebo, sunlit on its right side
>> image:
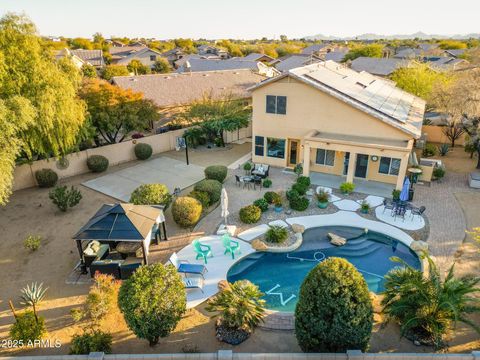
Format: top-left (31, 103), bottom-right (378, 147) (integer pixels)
top-left (73, 204), bottom-right (163, 241)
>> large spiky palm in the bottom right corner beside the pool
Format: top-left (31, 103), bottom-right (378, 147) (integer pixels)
top-left (382, 254), bottom-right (480, 347)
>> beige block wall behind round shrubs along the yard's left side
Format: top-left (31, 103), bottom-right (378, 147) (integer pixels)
top-left (13, 126), bottom-right (252, 191)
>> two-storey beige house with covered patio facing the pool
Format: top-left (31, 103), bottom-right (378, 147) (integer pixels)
top-left (251, 61), bottom-right (425, 189)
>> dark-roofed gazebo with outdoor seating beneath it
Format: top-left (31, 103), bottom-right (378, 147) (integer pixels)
top-left (73, 203), bottom-right (167, 277)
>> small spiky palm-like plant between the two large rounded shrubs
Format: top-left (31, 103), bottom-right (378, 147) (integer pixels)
top-left (207, 280), bottom-right (265, 331)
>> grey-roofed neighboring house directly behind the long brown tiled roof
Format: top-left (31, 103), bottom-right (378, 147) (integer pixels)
top-left (177, 58), bottom-right (279, 77)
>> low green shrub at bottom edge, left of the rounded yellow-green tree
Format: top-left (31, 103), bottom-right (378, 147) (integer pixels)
top-left (70, 330), bottom-right (113, 355)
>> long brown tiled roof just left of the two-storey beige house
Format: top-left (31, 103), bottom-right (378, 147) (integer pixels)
top-left (113, 70), bottom-right (266, 107)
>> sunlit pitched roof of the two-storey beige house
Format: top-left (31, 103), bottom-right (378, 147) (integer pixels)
top-left (251, 61), bottom-right (425, 138)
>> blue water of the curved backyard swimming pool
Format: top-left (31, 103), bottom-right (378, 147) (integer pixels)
top-left (227, 226), bottom-right (421, 312)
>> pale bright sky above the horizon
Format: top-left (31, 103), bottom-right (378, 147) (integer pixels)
top-left (0, 0), bottom-right (480, 39)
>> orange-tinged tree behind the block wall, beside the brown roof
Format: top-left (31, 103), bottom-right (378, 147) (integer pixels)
top-left (80, 79), bottom-right (159, 144)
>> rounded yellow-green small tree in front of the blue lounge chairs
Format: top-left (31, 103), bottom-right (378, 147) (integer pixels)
top-left (118, 264), bottom-right (187, 346)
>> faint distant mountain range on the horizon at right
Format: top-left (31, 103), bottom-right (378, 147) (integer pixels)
top-left (305, 31), bottom-right (480, 41)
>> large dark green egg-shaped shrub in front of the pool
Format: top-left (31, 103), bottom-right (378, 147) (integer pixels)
top-left (295, 257), bottom-right (373, 353)
